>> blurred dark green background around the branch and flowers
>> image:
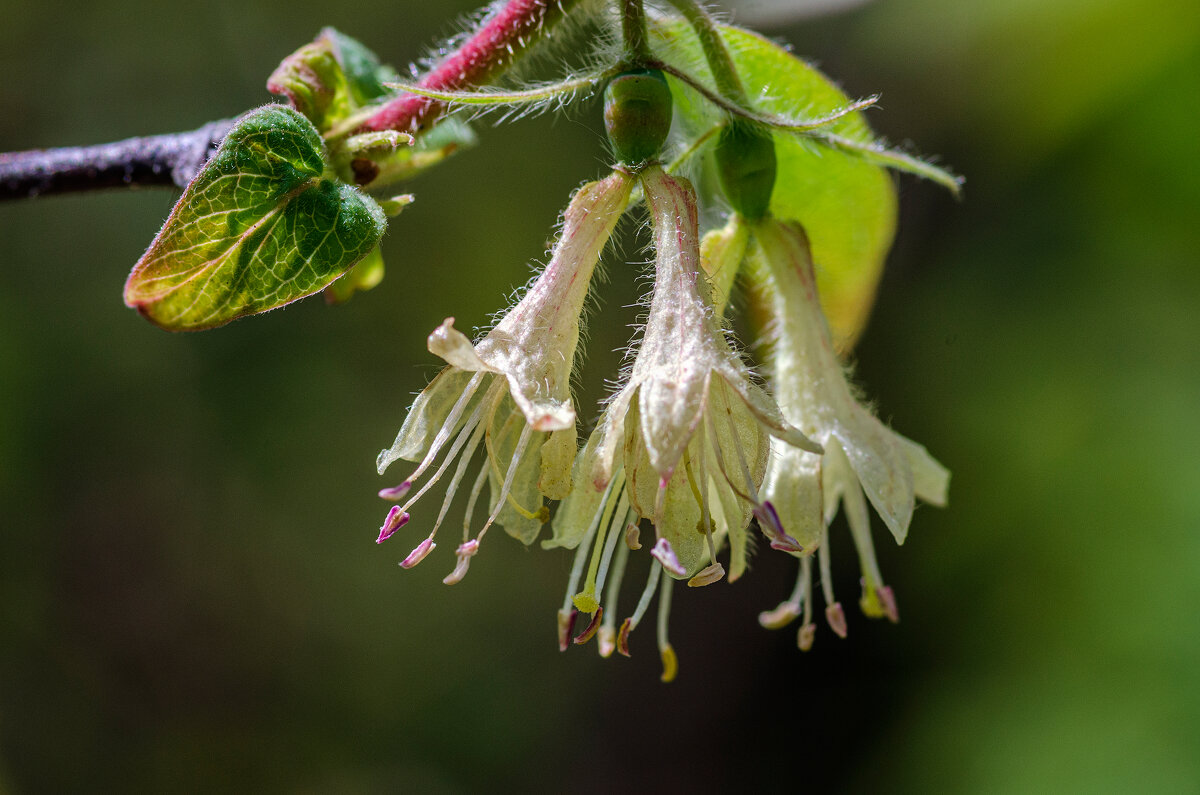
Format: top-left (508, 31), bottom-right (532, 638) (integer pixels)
top-left (0, 0), bottom-right (1200, 793)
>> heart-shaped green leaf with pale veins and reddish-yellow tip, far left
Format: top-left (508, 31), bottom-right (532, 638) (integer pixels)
top-left (125, 106), bottom-right (386, 330)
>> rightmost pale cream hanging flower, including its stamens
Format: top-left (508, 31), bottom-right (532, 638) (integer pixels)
top-left (752, 216), bottom-right (949, 648)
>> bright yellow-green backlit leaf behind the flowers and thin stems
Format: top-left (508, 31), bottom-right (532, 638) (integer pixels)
top-left (654, 20), bottom-right (896, 349)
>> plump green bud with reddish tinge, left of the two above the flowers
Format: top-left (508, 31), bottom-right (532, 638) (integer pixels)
top-left (604, 70), bottom-right (672, 166)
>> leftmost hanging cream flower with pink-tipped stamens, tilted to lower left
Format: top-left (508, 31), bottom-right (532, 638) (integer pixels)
top-left (378, 172), bottom-right (632, 584)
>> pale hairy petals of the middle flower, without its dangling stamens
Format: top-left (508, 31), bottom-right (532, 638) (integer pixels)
top-left (571, 167), bottom-right (821, 578)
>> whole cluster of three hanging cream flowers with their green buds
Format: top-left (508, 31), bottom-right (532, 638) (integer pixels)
top-left (378, 35), bottom-right (948, 681)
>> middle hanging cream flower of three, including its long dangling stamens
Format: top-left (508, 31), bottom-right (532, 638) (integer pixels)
top-left (548, 166), bottom-right (821, 676)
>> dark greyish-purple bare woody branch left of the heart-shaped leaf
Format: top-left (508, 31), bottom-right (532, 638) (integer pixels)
top-left (0, 120), bottom-right (233, 202)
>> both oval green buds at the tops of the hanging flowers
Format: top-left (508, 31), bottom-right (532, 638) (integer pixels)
top-left (604, 68), bottom-right (775, 221)
